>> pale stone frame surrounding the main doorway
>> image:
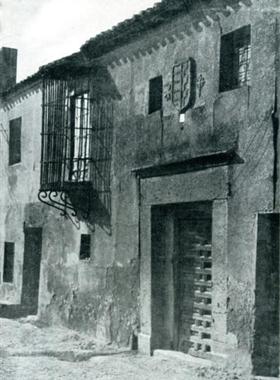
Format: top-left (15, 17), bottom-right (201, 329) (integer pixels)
top-left (138, 166), bottom-right (228, 356)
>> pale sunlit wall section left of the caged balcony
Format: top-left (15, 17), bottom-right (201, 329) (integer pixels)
top-left (0, 83), bottom-right (41, 304)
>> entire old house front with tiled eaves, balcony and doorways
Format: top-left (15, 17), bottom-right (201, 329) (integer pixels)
top-left (0, 0), bottom-right (280, 375)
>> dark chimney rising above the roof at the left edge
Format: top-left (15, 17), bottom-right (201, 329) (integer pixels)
top-left (0, 47), bottom-right (17, 93)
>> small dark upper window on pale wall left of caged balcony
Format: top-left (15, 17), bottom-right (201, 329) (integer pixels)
top-left (9, 117), bottom-right (21, 165)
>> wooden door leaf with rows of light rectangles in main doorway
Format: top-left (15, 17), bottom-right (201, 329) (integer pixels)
top-left (174, 205), bottom-right (212, 356)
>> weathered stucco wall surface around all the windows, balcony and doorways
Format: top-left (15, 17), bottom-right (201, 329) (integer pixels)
top-left (0, 0), bottom-right (279, 372)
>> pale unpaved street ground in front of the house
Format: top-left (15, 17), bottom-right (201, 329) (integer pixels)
top-left (0, 319), bottom-right (274, 380)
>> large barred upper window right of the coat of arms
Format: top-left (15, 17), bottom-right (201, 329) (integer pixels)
top-left (220, 25), bottom-right (251, 91)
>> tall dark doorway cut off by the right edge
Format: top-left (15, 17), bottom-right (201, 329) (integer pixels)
top-left (253, 214), bottom-right (279, 376)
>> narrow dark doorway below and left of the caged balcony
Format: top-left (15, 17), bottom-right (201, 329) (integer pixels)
top-left (0, 228), bottom-right (42, 319)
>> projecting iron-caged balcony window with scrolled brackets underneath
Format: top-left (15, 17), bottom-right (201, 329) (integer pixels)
top-left (39, 76), bottom-right (113, 229)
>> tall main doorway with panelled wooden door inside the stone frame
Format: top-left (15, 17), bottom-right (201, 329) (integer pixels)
top-left (152, 202), bottom-right (212, 357)
